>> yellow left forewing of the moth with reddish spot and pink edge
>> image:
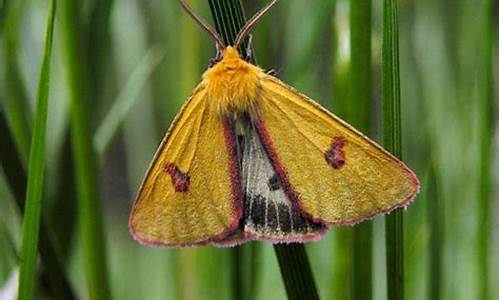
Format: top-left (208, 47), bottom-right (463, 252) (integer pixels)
top-left (129, 86), bottom-right (242, 247)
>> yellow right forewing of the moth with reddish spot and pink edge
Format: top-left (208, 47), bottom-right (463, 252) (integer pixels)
top-left (256, 76), bottom-right (420, 225)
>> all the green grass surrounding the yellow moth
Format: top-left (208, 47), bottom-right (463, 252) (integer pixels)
top-left (0, 0), bottom-right (498, 300)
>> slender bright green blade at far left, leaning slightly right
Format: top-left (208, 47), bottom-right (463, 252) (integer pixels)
top-left (18, 0), bottom-right (56, 300)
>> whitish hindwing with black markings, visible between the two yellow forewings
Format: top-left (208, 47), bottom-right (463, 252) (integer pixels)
top-left (236, 121), bottom-right (325, 242)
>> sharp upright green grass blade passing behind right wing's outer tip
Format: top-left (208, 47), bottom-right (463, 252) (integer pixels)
top-left (382, 0), bottom-right (404, 300)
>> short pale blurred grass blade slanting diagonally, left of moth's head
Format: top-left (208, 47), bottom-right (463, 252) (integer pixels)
top-left (94, 47), bottom-right (164, 158)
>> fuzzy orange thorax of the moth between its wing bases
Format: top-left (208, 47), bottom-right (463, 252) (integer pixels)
top-left (203, 46), bottom-right (264, 117)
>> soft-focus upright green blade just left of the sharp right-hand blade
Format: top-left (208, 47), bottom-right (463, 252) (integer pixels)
top-left (345, 0), bottom-right (373, 299)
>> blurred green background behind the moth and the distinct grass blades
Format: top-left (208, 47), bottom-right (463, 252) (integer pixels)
top-left (0, 0), bottom-right (498, 299)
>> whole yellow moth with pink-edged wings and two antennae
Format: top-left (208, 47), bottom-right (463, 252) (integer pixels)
top-left (129, 0), bottom-right (420, 247)
